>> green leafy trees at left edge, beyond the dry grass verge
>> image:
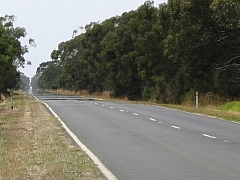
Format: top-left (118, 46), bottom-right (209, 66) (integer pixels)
top-left (0, 15), bottom-right (34, 93)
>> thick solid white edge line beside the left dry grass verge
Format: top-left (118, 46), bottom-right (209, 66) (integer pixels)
top-left (34, 96), bottom-right (117, 180)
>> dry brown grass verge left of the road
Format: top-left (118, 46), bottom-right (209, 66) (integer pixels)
top-left (0, 94), bottom-right (104, 180)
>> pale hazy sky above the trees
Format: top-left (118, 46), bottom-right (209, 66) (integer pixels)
top-left (0, 0), bottom-right (167, 77)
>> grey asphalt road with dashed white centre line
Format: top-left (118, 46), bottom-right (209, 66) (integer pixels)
top-left (33, 95), bottom-right (240, 180)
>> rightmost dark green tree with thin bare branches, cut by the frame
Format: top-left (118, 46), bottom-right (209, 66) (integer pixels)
top-left (211, 0), bottom-right (240, 97)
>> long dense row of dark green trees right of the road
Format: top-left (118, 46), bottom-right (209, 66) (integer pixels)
top-left (37, 0), bottom-right (240, 103)
